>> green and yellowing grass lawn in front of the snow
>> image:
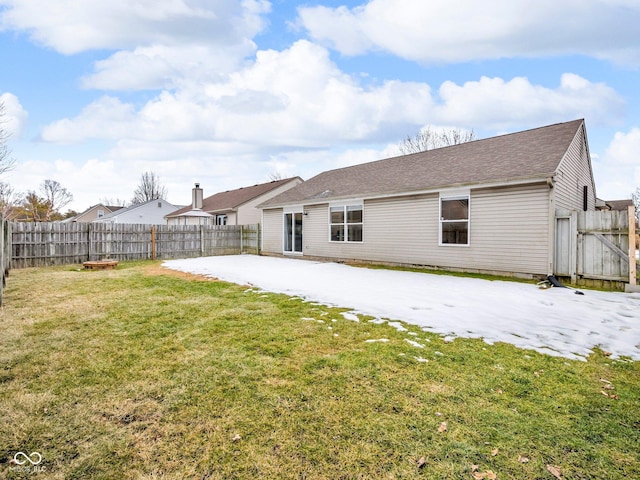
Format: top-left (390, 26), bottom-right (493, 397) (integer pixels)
top-left (0, 262), bottom-right (640, 480)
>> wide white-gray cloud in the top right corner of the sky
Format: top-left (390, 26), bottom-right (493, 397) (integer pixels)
top-left (298, 0), bottom-right (640, 66)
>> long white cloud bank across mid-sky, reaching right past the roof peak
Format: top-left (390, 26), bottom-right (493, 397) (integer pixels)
top-left (37, 40), bottom-right (624, 151)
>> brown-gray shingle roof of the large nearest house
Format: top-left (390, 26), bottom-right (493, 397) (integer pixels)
top-left (260, 119), bottom-right (584, 207)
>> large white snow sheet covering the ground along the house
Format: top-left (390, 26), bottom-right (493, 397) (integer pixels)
top-left (163, 255), bottom-right (640, 360)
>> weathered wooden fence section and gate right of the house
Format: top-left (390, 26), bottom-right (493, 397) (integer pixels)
top-left (554, 207), bottom-right (638, 287)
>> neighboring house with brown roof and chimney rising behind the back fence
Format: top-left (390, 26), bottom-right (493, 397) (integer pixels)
top-left (166, 177), bottom-right (302, 225)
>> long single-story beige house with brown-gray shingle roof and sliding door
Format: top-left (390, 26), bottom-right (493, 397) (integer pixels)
top-left (260, 120), bottom-right (596, 276)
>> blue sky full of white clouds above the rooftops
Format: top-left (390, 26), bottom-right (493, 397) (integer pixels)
top-left (0, 0), bottom-right (640, 211)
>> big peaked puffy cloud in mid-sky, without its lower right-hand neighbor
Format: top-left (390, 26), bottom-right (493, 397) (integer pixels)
top-left (42, 41), bottom-right (432, 147)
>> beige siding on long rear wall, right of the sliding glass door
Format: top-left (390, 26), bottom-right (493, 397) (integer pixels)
top-left (300, 184), bottom-right (549, 275)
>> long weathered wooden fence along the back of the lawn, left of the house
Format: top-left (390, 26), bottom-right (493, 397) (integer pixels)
top-left (11, 222), bottom-right (260, 268)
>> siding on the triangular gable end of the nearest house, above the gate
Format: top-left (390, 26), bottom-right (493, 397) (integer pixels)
top-left (553, 126), bottom-right (596, 210)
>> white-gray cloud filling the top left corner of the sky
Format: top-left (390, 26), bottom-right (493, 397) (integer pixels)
top-left (0, 0), bottom-right (270, 90)
